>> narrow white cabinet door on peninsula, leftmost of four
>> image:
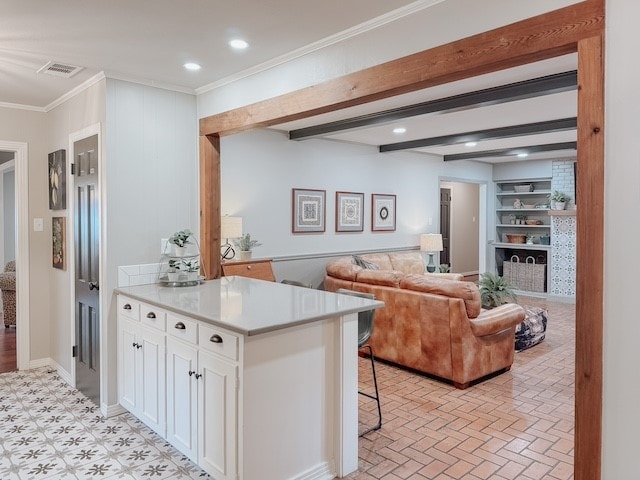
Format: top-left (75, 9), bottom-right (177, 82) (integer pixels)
top-left (118, 316), bottom-right (138, 415)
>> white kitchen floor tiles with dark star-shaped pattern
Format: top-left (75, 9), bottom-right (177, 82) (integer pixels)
top-left (0, 369), bottom-right (211, 480)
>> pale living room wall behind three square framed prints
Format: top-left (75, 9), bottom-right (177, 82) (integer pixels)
top-left (221, 130), bottom-right (491, 264)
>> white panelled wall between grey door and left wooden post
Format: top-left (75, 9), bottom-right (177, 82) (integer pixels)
top-left (101, 79), bottom-right (199, 405)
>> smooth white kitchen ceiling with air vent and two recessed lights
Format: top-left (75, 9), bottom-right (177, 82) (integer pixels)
top-left (0, 0), bottom-right (420, 108)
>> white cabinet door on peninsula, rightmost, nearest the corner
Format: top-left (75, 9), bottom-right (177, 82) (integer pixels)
top-left (198, 351), bottom-right (238, 480)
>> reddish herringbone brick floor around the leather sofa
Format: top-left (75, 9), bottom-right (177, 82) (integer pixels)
top-left (347, 296), bottom-right (575, 480)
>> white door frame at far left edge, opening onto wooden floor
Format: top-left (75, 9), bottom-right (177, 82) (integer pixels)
top-left (0, 140), bottom-right (31, 370)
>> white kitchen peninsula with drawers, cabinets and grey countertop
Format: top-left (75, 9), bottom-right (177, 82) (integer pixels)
top-left (116, 277), bottom-right (383, 480)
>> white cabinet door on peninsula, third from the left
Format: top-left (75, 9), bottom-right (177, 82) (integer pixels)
top-left (167, 337), bottom-right (198, 462)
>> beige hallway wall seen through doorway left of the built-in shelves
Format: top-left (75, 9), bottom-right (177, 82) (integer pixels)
top-left (440, 182), bottom-right (486, 274)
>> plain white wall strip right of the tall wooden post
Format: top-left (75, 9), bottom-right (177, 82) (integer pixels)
top-left (604, 0), bottom-right (640, 479)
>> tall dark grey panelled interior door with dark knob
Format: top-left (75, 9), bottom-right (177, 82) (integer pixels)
top-left (73, 135), bottom-right (100, 405)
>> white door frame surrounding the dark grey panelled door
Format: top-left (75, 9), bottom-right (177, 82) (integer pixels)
top-left (67, 123), bottom-right (108, 415)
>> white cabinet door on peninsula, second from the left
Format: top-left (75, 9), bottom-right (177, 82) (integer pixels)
top-left (136, 326), bottom-right (167, 437)
